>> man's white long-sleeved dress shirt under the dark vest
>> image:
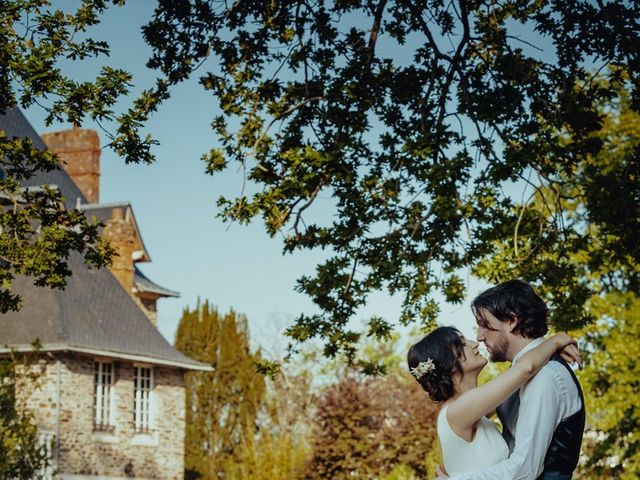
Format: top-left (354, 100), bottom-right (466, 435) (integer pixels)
top-left (451, 338), bottom-right (582, 480)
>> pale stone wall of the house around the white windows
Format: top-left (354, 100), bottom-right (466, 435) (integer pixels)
top-left (28, 353), bottom-right (185, 480)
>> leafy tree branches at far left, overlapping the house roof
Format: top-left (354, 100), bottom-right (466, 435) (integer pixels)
top-left (0, 0), bottom-right (166, 313)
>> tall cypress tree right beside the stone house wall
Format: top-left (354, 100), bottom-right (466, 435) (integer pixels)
top-left (175, 301), bottom-right (265, 479)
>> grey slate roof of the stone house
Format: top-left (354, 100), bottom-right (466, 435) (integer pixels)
top-left (0, 109), bottom-right (211, 370)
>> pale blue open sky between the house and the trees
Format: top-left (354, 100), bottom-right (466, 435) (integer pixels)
top-left (21, 1), bottom-right (487, 351)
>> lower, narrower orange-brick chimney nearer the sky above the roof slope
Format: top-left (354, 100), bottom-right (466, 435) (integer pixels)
top-left (102, 207), bottom-right (139, 295)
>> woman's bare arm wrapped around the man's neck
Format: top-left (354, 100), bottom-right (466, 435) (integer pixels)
top-left (447, 333), bottom-right (575, 433)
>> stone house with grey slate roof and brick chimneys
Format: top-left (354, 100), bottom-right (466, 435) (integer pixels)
top-left (0, 109), bottom-right (211, 480)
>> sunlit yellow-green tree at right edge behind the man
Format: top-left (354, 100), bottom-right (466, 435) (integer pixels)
top-left (476, 79), bottom-right (640, 472)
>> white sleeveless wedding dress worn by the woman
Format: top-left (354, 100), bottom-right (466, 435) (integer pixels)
top-left (438, 405), bottom-right (509, 476)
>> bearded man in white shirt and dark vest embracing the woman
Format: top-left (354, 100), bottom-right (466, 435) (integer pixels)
top-left (438, 280), bottom-right (585, 480)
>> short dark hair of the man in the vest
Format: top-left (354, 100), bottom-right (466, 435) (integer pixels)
top-left (471, 279), bottom-right (549, 338)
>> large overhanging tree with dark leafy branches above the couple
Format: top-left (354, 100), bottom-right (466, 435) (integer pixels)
top-left (132, 0), bottom-right (640, 364)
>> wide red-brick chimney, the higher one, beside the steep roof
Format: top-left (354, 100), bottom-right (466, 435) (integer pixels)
top-left (42, 127), bottom-right (100, 203)
